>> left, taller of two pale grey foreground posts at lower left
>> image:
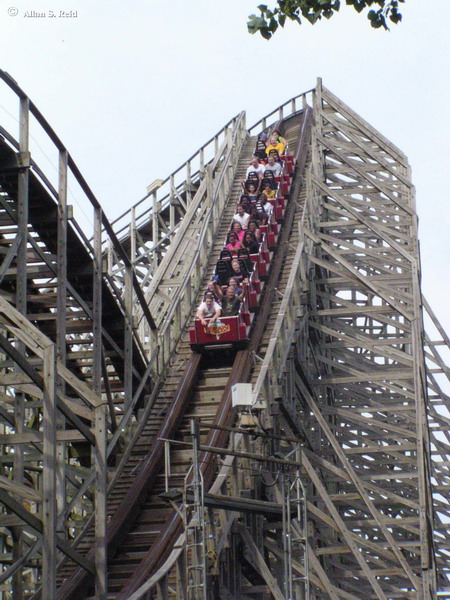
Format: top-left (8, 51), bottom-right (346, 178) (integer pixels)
top-left (42, 344), bottom-right (57, 599)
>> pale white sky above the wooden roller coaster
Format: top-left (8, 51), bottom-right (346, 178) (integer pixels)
top-left (0, 0), bottom-right (450, 338)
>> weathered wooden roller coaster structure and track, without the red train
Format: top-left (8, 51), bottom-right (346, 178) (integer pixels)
top-left (0, 71), bottom-right (450, 600)
